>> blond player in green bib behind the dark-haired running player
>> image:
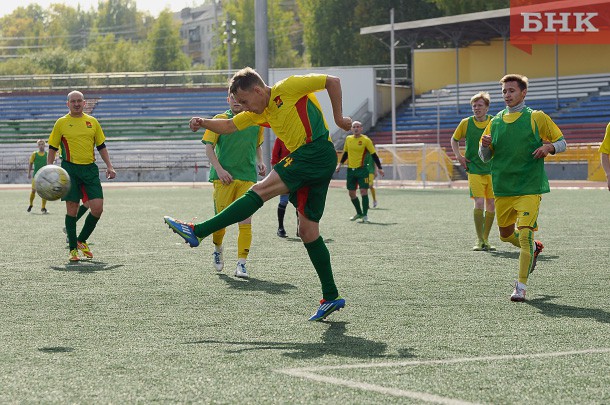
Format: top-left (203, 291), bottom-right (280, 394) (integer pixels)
top-left (451, 91), bottom-right (496, 251)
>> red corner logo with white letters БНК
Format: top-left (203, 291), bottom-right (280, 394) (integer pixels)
top-left (510, 0), bottom-right (610, 53)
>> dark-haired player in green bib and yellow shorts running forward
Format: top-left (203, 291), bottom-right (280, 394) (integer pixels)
top-left (479, 74), bottom-right (567, 302)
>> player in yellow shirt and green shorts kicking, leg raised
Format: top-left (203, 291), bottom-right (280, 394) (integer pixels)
top-left (164, 67), bottom-right (352, 321)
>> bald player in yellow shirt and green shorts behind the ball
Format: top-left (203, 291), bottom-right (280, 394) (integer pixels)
top-left (47, 90), bottom-right (116, 262)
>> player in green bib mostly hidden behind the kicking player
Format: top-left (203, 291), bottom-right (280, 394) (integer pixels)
top-left (201, 90), bottom-right (267, 278)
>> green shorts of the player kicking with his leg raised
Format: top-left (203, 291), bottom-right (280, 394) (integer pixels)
top-left (273, 138), bottom-right (337, 222)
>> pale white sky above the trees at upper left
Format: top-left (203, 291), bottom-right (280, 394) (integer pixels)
top-left (0, 0), bottom-right (204, 17)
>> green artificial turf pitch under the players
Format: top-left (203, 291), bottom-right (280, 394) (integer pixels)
top-left (0, 186), bottom-right (610, 404)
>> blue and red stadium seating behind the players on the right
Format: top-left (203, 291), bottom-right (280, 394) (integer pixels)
top-left (369, 74), bottom-right (610, 177)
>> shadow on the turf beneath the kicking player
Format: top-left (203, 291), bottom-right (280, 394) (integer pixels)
top-left (185, 322), bottom-right (415, 360)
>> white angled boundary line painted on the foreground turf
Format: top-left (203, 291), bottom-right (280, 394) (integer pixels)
top-left (275, 348), bottom-right (610, 405)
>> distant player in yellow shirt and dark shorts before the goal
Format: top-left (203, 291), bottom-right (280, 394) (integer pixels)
top-left (336, 121), bottom-right (383, 223)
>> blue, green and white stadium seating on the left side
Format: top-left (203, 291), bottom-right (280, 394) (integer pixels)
top-left (0, 89), bottom-right (227, 182)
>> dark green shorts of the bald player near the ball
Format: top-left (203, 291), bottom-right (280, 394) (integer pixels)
top-left (61, 160), bottom-right (104, 202)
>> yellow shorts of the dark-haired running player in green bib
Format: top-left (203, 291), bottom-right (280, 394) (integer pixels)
top-left (495, 194), bottom-right (542, 230)
